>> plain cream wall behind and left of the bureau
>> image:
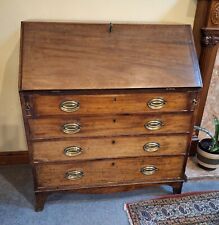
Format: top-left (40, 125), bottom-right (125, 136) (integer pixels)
top-left (0, 0), bottom-right (197, 151)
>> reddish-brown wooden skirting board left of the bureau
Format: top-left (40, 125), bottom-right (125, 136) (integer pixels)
top-left (0, 151), bottom-right (29, 165)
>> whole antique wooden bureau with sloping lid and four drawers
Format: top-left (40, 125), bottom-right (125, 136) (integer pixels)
top-left (19, 22), bottom-right (202, 210)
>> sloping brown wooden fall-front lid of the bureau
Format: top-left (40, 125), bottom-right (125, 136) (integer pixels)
top-left (20, 22), bottom-right (202, 90)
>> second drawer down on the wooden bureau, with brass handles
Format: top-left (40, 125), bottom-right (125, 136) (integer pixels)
top-left (29, 113), bottom-right (192, 139)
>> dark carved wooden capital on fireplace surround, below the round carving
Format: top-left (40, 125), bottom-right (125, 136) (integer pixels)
top-left (201, 28), bottom-right (219, 47)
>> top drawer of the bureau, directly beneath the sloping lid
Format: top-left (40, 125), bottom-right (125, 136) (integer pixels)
top-left (32, 92), bottom-right (192, 116)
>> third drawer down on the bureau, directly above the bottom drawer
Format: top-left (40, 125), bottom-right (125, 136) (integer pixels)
top-left (32, 134), bottom-right (189, 162)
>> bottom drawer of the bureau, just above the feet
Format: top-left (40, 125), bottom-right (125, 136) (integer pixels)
top-left (35, 156), bottom-right (184, 188)
